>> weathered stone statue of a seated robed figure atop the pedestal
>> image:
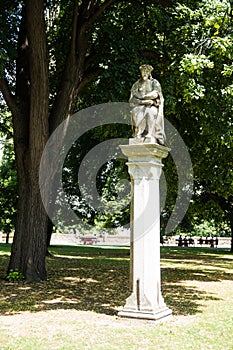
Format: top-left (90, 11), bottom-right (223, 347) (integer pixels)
top-left (129, 64), bottom-right (165, 145)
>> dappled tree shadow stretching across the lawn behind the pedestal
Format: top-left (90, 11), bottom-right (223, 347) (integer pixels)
top-left (0, 247), bottom-right (233, 315)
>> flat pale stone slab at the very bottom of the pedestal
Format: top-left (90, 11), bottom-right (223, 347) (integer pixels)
top-left (118, 308), bottom-right (172, 323)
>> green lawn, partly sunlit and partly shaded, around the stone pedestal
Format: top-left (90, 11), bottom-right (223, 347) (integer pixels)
top-left (0, 244), bottom-right (233, 350)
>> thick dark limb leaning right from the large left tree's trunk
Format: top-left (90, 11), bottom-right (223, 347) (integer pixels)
top-left (50, 0), bottom-right (119, 132)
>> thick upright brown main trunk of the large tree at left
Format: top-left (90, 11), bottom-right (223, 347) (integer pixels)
top-left (8, 0), bottom-right (49, 280)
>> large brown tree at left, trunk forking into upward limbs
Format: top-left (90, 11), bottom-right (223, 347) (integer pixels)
top-left (0, 0), bottom-right (127, 280)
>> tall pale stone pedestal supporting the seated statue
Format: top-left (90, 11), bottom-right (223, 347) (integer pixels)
top-left (119, 139), bottom-right (172, 321)
